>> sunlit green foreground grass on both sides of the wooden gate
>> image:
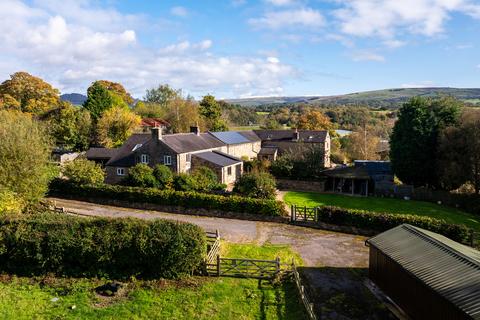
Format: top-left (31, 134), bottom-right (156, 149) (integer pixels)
top-left (0, 243), bottom-right (305, 320)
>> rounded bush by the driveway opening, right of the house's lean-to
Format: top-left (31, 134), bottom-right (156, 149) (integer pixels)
top-left (233, 172), bottom-right (277, 199)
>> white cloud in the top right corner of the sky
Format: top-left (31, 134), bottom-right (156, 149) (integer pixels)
top-left (335, 0), bottom-right (480, 38)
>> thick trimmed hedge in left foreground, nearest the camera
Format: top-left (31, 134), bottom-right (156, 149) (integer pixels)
top-left (0, 213), bottom-right (206, 279)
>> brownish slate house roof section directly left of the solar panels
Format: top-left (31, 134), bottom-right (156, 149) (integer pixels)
top-left (162, 133), bottom-right (225, 153)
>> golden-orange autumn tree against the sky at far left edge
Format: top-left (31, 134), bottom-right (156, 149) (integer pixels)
top-left (0, 72), bottom-right (60, 115)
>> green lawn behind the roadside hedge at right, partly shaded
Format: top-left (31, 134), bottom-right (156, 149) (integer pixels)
top-left (284, 191), bottom-right (480, 231)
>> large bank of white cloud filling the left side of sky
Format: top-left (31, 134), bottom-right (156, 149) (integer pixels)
top-left (0, 0), bottom-right (297, 96)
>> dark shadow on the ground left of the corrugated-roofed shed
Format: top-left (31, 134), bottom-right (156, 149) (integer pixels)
top-left (298, 267), bottom-right (396, 320)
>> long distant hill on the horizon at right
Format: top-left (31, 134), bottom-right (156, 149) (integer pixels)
top-left (226, 88), bottom-right (480, 109)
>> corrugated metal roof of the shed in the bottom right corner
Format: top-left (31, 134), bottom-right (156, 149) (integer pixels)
top-left (367, 224), bottom-right (480, 319)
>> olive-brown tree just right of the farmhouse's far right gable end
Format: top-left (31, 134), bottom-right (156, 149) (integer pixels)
top-left (344, 128), bottom-right (380, 160)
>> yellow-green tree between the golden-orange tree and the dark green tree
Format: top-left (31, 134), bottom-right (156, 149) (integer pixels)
top-left (48, 102), bottom-right (92, 151)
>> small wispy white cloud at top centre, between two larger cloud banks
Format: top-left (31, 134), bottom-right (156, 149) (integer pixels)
top-left (248, 8), bottom-right (325, 30)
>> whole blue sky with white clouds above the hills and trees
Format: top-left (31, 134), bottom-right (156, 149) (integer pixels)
top-left (0, 0), bottom-right (480, 98)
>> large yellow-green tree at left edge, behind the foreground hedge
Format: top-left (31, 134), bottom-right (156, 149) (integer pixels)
top-left (0, 110), bottom-right (52, 203)
